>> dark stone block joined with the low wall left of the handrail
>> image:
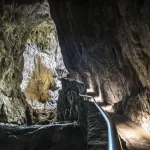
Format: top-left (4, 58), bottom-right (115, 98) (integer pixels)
top-left (57, 78), bottom-right (127, 150)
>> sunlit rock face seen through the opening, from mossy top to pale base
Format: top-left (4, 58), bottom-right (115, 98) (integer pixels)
top-left (21, 22), bottom-right (68, 112)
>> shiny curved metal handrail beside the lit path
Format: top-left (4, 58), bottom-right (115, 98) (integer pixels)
top-left (79, 94), bottom-right (123, 150)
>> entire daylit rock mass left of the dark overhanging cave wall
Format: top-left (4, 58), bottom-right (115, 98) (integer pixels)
top-left (0, 1), bottom-right (68, 124)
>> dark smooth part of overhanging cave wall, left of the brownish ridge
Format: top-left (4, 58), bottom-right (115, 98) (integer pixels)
top-left (50, 0), bottom-right (142, 103)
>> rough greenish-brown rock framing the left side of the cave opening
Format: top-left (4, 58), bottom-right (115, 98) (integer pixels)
top-left (0, 1), bottom-right (65, 124)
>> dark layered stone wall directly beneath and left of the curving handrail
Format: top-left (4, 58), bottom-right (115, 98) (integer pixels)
top-left (87, 102), bottom-right (108, 150)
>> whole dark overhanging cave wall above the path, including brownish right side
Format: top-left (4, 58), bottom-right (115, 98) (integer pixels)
top-left (49, 0), bottom-right (150, 130)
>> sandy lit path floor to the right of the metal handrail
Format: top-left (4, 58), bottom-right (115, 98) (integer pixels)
top-left (105, 109), bottom-right (150, 150)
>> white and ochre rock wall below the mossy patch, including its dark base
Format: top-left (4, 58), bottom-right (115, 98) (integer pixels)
top-left (21, 27), bottom-right (68, 124)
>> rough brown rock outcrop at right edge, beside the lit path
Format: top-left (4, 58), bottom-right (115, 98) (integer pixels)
top-left (114, 90), bottom-right (150, 132)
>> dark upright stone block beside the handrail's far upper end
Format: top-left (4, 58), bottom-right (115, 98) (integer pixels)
top-left (57, 78), bottom-right (86, 125)
